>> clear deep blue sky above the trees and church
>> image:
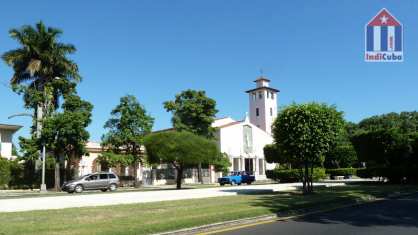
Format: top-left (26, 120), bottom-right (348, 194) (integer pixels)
top-left (0, 0), bottom-right (418, 141)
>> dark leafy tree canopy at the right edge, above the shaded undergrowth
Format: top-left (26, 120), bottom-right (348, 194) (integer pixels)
top-left (351, 112), bottom-right (418, 167)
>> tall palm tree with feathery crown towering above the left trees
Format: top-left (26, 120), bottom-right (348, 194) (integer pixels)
top-left (2, 21), bottom-right (81, 135)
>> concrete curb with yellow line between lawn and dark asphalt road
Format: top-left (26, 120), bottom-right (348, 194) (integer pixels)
top-left (155, 192), bottom-right (416, 235)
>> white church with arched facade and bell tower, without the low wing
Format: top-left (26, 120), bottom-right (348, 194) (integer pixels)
top-left (212, 77), bottom-right (279, 180)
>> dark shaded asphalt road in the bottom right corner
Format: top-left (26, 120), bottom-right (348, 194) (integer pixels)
top-left (219, 195), bottom-right (418, 235)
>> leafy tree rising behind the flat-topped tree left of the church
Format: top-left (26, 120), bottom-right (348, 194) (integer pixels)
top-left (164, 89), bottom-right (218, 183)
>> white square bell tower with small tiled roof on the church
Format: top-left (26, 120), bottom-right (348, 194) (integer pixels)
top-left (246, 76), bottom-right (279, 134)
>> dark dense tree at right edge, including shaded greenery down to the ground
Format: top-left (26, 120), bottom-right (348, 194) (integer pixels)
top-left (350, 111), bottom-right (418, 183)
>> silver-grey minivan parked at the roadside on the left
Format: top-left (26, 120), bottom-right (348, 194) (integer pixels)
top-left (61, 172), bottom-right (119, 193)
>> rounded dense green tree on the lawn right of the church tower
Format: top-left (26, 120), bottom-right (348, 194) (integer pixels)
top-left (273, 103), bottom-right (344, 193)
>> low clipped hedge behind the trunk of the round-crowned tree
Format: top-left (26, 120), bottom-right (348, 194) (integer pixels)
top-left (266, 168), bottom-right (326, 183)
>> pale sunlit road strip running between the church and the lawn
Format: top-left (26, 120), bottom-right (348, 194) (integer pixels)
top-left (0, 183), bottom-right (344, 212)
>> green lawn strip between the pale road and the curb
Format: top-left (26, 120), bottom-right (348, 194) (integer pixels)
top-left (0, 185), bottom-right (418, 234)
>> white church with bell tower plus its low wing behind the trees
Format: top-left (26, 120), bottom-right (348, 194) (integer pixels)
top-left (78, 77), bottom-right (279, 185)
